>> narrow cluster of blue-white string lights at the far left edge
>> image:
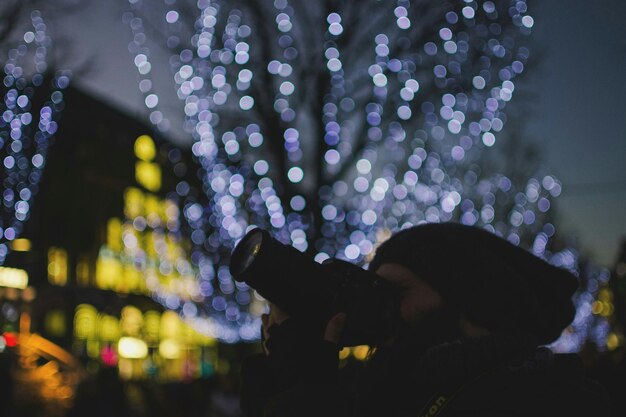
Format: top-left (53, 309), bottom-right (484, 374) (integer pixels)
top-left (0, 11), bottom-right (70, 265)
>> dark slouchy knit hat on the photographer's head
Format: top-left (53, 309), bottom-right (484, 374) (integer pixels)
top-left (369, 223), bottom-right (578, 344)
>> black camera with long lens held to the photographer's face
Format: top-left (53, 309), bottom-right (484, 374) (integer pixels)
top-left (230, 229), bottom-right (400, 346)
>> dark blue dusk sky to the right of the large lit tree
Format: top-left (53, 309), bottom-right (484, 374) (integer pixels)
top-left (526, 0), bottom-right (626, 265)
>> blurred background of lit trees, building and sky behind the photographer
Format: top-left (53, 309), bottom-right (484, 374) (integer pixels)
top-left (0, 0), bottom-right (626, 416)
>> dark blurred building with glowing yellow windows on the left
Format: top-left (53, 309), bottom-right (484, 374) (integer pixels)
top-left (0, 89), bottom-right (219, 412)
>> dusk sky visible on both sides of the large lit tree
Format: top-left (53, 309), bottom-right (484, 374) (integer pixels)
top-left (56, 0), bottom-right (626, 266)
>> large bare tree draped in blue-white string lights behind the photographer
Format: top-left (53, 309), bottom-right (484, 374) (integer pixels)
top-left (124, 0), bottom-right (604, 348)
